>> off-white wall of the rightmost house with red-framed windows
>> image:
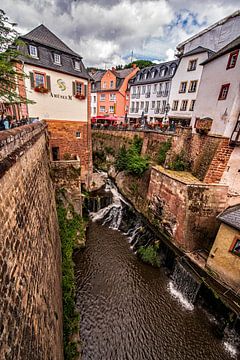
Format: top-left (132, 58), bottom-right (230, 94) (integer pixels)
top-left (192, 54), bottom-right (240, 137)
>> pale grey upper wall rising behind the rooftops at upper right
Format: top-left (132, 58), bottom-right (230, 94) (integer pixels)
top-left (184, 15), bottom-right (240, 53)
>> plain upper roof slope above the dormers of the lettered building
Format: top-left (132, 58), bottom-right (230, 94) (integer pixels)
top-left (20, 24), bottom-right (81, 57)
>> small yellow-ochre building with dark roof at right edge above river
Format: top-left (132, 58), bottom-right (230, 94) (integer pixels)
top-left (207, 204), bottom-right (240, 292)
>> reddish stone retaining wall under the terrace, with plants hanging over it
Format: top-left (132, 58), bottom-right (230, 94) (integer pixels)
top-left (92, 127), bottom-right (227, 181)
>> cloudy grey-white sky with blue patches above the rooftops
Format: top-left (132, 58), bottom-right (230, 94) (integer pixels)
top-left (1, 0), bottom-right (240, 67)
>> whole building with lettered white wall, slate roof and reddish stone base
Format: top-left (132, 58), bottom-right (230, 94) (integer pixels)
top-left (17, 25), bottom-right (92, 182)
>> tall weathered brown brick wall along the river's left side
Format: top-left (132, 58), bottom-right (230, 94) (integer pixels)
top-left (0, 124), bottom-right (63, 360)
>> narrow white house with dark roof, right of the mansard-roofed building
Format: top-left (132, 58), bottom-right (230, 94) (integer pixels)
top-left (168, 46), bottom-right (213, 125)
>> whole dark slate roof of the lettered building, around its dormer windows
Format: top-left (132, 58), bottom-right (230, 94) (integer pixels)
top-left (19, 25), bottom-right (90, 79)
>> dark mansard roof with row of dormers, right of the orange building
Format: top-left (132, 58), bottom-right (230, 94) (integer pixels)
top-left (131, 59), bottom-right (179, 85)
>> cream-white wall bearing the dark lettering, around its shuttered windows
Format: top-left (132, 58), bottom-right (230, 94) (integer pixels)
top-left (24, 64), bottom-right (88, 121)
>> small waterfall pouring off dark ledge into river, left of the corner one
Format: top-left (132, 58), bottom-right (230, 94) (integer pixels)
top-left (169, 261), bottom-right (201, 310)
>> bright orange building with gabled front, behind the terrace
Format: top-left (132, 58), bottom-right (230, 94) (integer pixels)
top-left (92, 66), bottom-right (139, 121)
